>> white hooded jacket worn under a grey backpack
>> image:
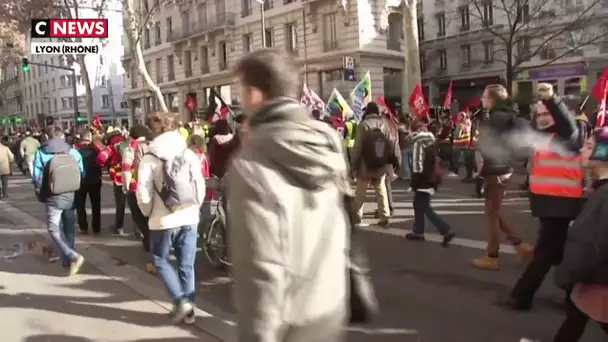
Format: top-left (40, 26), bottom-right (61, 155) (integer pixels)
top-left (136, 131), bottom-right (205, 230)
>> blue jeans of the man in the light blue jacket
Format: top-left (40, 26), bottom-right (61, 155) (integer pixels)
top-left (46, 206), bottom-right (79, 267)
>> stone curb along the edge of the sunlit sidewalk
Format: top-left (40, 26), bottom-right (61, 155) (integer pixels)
top-left (0, 201), bottom-right (237, 342)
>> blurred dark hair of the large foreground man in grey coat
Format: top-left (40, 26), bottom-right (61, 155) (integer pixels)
top-left (234, 49), bottom-right (300, 99)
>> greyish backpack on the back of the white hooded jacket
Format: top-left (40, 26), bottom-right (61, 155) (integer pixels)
top-left (156, 149), bottom-right (201, 211)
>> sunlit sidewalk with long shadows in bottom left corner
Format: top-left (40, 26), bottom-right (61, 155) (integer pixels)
top-left (0, 216), bottom-right (218, 342)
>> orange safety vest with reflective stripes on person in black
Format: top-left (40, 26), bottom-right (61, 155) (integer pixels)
top-left (529, 140), bottom-right (585, 198)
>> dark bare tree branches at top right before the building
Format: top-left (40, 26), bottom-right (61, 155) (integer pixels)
top-left (469, 0), bottom-right (608, 91)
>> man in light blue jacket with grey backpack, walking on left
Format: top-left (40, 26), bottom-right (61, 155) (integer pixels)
top-left (32, 127), bottom-right (85, 275)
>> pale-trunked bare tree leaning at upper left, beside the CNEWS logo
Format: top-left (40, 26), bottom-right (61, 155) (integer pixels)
top-left (123, 0), bottom-right (184, 112)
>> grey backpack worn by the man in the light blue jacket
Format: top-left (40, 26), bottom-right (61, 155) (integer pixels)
top-left (48, 152), bottom-right (81, 195)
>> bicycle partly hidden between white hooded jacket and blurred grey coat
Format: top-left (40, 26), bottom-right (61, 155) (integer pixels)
top-left (199, 177), bottom-right (231, 269)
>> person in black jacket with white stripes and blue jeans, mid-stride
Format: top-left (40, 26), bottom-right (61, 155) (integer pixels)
top-left (405, 121), bottom-right (455, 247)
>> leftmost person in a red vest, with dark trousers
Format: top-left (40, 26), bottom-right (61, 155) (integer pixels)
top-left (97, 130), bottom-right (126, 236)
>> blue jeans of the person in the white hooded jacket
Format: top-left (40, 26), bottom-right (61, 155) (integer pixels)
top-left (150, 225), bottom-right (198, 303)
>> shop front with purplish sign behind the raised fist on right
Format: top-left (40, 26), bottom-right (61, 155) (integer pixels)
top-left (513, 63), bottom-right (588, 104)
